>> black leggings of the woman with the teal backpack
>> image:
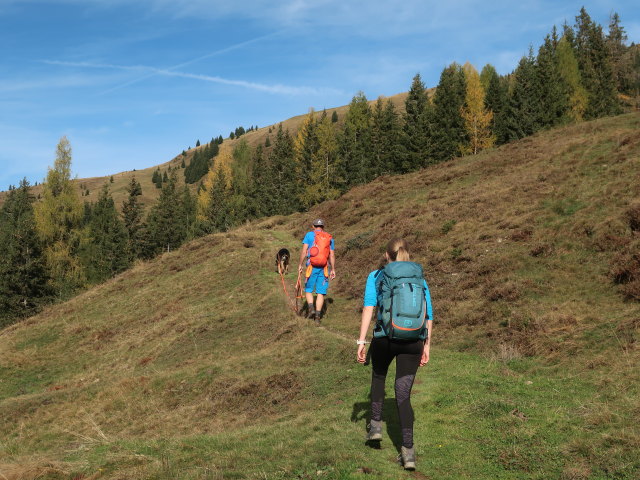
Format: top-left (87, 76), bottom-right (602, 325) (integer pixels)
top-left (369, 337), bottom-right (424, 448)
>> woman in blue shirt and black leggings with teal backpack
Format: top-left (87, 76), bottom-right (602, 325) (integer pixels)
top-left (356, 239), bottom-right (433, 470)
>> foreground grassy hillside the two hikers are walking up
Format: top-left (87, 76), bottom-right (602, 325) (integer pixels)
top-left (0, 115), bottom-right (640, 479)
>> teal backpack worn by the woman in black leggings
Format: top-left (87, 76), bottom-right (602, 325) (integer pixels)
top-left (376, 262), bottom-right (428, 341)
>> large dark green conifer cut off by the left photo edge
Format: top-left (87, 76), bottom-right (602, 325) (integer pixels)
top-left (0, 178), bottom-right (50, 328)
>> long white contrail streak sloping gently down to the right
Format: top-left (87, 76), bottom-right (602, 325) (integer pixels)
top-left (43, 60), bottom-right (341, 95)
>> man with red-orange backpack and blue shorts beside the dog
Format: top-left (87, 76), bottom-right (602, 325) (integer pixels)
top-left (298, 218), bottom-right (336, 324)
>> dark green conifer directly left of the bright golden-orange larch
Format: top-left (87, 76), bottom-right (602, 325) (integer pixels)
top-left (429, 63), bottom-right (467, 162)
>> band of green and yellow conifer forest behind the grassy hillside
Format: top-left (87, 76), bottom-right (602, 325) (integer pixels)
top-left (0, 8), bottom-right (640, 327)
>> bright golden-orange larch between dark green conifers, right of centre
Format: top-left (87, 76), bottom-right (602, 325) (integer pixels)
top-left (460, 62), bottom-right (495, 155)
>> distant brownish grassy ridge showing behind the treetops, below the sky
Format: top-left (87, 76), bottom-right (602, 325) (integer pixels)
top-left (0, 93), bottom-right (407, 213)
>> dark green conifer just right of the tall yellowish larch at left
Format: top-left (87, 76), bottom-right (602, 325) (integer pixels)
top-left (83, 184), bottom-right (131, 283)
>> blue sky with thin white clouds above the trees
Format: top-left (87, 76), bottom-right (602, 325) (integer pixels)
top-left (0, 0), bottom-right (640, 190)
